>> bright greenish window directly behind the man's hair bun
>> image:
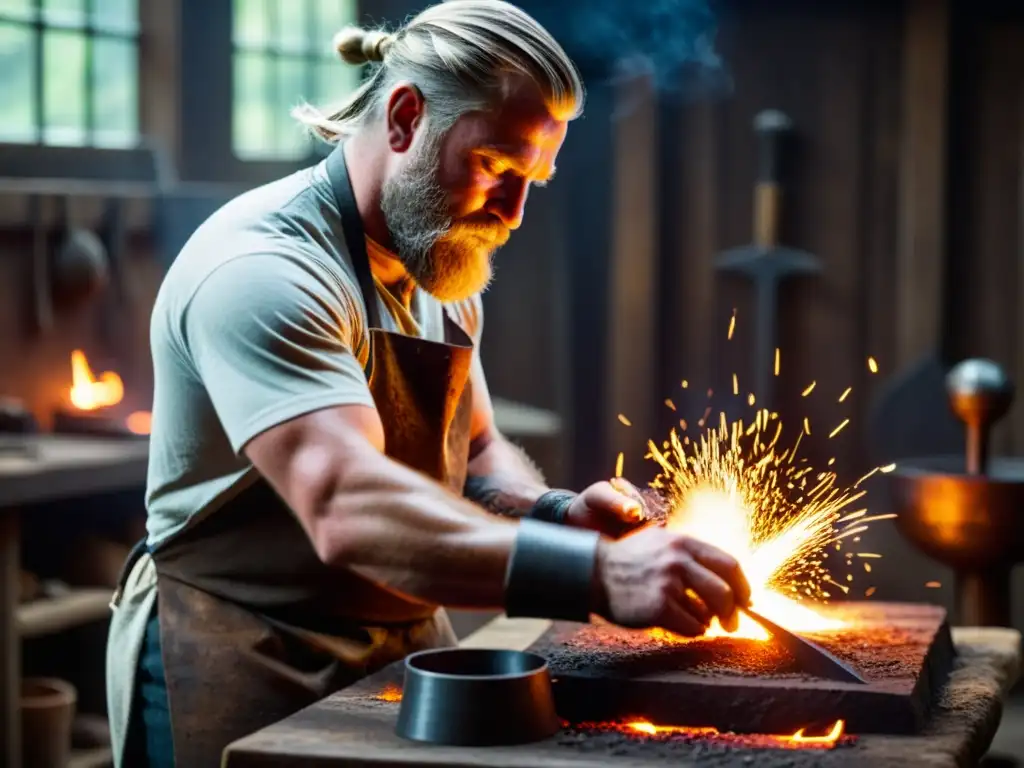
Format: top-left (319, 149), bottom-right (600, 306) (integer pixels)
top-left (234, 0), bottom-right (361, 160)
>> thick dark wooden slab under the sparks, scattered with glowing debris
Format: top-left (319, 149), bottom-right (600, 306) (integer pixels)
top-left (530, 602), bottom-right (953, 733)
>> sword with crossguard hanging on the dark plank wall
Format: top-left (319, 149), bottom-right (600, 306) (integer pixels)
top-left (715, 110), bottom-right (821, 410)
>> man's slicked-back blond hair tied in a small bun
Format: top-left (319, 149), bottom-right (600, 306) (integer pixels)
top-left (292, 0), bottom-right (585, 141)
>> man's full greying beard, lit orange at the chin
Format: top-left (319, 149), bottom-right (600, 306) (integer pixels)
top-left (381, 135), bottom-right (495, 302)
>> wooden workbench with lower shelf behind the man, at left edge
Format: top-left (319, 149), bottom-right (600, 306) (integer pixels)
top-left (0, 435), bottom-right (148, 766)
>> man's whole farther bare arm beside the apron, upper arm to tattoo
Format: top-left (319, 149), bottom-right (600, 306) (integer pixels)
top-left (463, 355), bottom-right (549, 517)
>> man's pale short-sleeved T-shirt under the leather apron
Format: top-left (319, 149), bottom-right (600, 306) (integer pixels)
top-left (146, 162), bottom-right (483, 546)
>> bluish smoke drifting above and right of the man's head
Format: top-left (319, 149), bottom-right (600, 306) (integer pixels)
top-left (518, 0), bottom-right (732, 99)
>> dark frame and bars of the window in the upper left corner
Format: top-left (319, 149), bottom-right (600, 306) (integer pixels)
top-left (0, 0), bottom-right (159, 182)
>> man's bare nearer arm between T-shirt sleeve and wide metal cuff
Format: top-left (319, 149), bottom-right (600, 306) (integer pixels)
top-left (245, 406), bottom-right (517, 608)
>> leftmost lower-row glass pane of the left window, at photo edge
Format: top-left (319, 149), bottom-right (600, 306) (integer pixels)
top-left (0, 24), bottom-right (37, 141)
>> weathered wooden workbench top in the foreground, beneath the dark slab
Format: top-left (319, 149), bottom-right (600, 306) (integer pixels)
top-left (225, 617), bottom-right (1021, 768)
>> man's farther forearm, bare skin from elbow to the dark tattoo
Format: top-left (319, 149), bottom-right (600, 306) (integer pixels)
top-left (463, 432), bottom-right (549, 517)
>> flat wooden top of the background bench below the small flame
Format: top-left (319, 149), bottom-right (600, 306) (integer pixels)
top-left (0, 434), bottom-right (150, 509)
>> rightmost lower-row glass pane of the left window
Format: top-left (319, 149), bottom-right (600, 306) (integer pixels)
top-left (92, 38), bottom-right (138, 147)
